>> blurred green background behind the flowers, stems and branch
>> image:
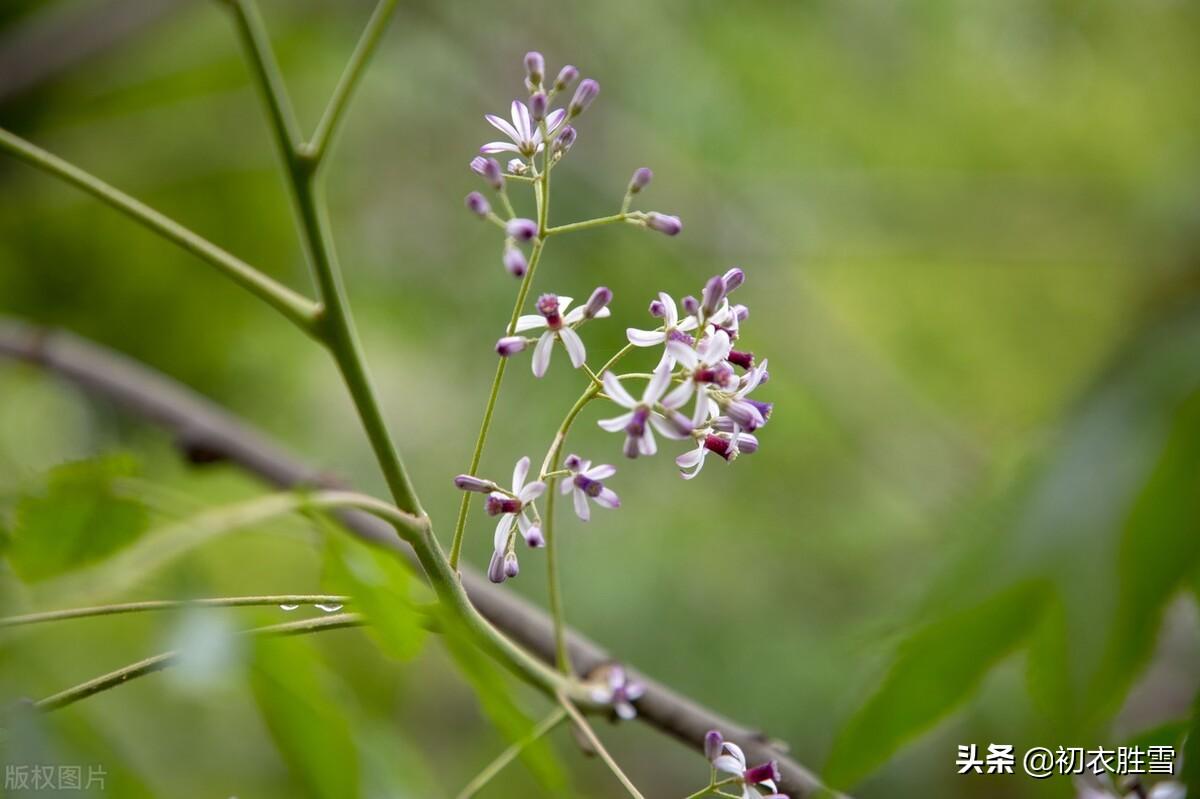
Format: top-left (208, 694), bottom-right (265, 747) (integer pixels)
top-left (0, 0), bottom-right (1200, 798)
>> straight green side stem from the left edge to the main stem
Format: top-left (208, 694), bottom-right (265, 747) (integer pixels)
top-left (0, 128), bottom-right (318, 328)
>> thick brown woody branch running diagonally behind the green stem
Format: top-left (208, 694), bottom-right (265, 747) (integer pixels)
top-left (0, 319), bottom-right (840, 799)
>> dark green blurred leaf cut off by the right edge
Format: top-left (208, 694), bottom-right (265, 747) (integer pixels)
top-left (1090, 392), bottom-right (1200, 715)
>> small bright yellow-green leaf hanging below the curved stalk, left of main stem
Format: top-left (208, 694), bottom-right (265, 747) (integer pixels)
top-left (322, 518), bottom-right (425, 660)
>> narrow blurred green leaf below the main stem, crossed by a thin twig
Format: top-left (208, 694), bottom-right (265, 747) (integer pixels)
top-left (438, 604), bottom-right (568, 794)
